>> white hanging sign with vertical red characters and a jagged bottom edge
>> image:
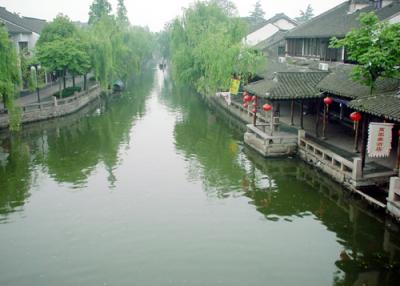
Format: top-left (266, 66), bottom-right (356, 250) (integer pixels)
top-left (368, 122), bottom-right (393, 158)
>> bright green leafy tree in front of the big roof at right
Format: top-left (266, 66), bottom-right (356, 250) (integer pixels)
top-left (331, 12), bottom-right (400, 93)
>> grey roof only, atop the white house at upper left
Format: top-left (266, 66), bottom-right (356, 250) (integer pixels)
top-left (0, 7), bottom-right (46, 34)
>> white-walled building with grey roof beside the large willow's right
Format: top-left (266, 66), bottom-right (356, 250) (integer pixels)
top-left (244, 13), bottom-right (297, 55)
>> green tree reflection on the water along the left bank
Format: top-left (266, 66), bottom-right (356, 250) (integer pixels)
top-left (0, 70), bottom-right (154, 216)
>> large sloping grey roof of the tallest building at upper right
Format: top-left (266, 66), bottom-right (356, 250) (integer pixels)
top-left (286, 1), bottom-right (400, 38)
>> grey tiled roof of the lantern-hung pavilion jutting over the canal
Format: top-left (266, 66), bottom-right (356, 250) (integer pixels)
top-left (245, 71), bottom-right (328, 100)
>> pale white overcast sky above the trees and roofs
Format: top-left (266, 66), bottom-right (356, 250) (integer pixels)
top-left (0, 0), bottom-right (345, 32)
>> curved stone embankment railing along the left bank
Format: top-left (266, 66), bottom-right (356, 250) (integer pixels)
top-left (0, 85), bottom-right (101, 128)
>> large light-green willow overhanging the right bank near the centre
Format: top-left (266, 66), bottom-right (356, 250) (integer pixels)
top-left (163, 1), bottom-right (262, 94)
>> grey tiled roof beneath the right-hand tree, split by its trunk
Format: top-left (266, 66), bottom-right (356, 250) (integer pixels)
top-left (317, 65), bottom-right (400, 99)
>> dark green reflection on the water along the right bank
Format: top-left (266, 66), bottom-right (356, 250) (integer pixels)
top-left (163, 81), bottom-right (400, 285)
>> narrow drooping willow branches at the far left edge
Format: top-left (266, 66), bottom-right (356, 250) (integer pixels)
top-left (0, 24), bottom-right (21, 130)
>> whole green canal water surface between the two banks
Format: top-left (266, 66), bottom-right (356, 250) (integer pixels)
top-left (0, 69), bottom-right (400, 286)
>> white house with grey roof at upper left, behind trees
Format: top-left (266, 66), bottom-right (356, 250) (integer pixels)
top-left (0, 7), bottom-right (46, 52)
